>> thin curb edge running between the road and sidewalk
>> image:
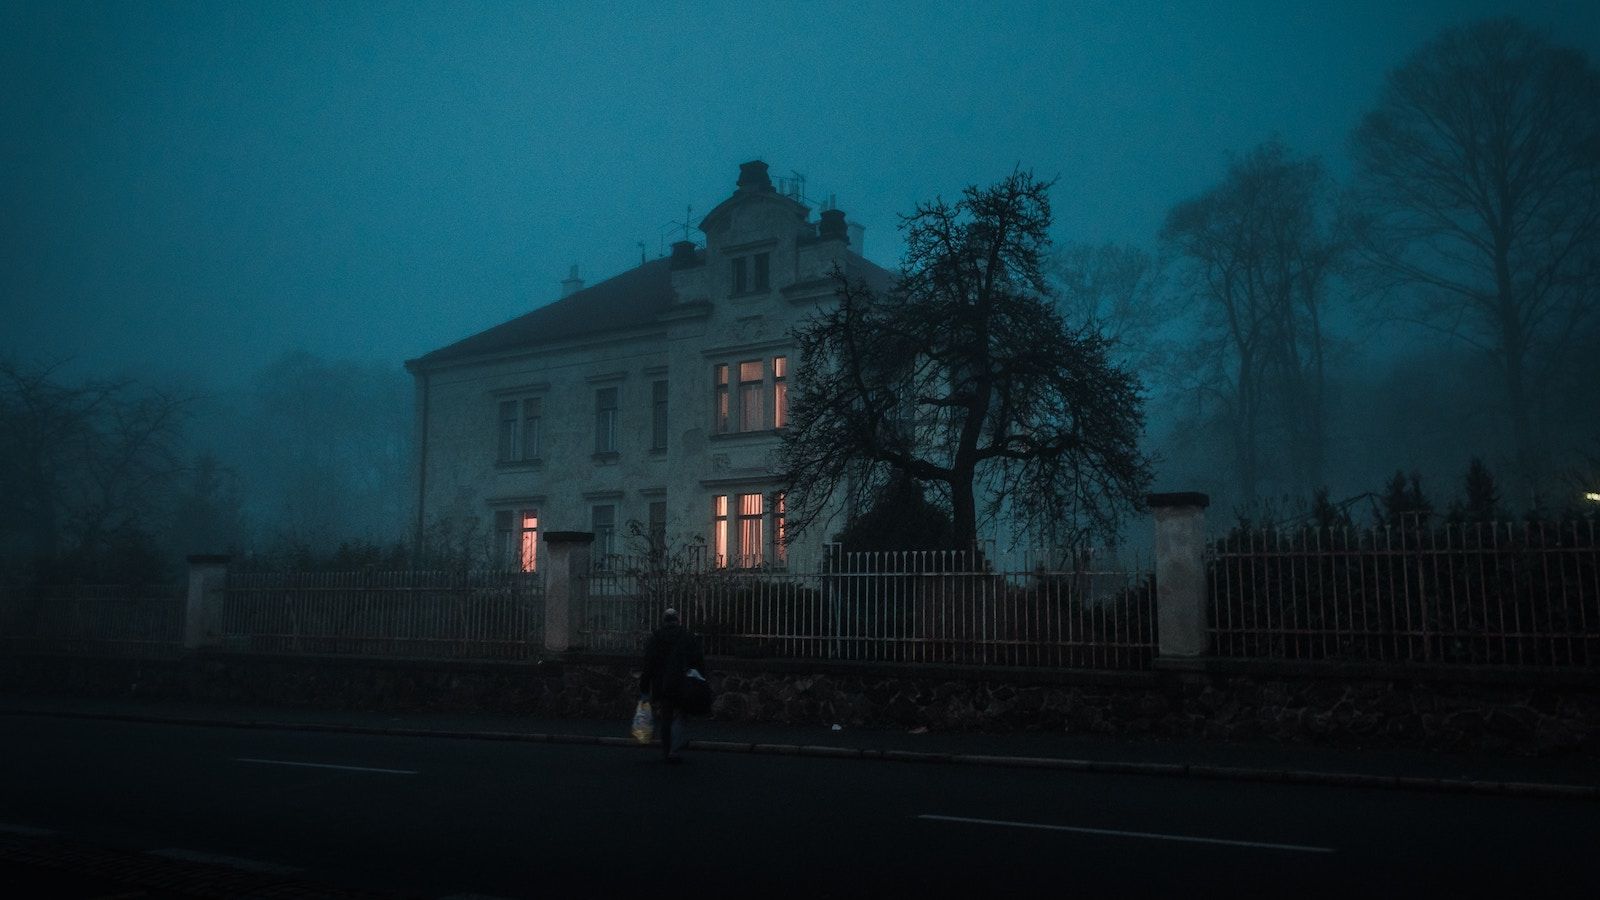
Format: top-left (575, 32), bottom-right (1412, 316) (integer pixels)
top-left (0, 709), bottom-right (1600, 801)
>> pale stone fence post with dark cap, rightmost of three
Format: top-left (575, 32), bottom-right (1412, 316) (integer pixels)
top-left (1146, 492), bottom-right (1211, 658)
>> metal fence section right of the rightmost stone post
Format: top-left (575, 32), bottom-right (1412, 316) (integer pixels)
top-left (1208, 522), bottom-right (1600, 668)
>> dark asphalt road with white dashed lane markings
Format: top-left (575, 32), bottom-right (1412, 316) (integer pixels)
top-left (0, 716), bottom-right (1600, 897)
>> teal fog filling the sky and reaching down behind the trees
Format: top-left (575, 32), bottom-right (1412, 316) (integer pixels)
top-left (0, 0), bottom-right (1600, 570)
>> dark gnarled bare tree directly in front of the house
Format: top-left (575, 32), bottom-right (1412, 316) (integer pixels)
top-left (781, 173), bottom-right (1150, 548)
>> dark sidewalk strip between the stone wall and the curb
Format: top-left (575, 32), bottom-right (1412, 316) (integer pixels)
top-left (0, 697), bottom-right (1600, 799)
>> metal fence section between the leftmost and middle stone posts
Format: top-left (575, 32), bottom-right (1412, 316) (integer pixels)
top-left (218, 572), bottom-right (544, 660)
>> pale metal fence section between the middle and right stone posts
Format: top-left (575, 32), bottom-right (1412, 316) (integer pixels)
top-left (578, 551), bottom-right (1155, 669)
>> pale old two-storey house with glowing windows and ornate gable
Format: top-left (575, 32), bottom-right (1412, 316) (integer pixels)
top-left (406, 162), bottom-right (890, 570)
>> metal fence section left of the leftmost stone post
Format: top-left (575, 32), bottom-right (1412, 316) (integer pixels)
top-left (0, 585), bottom-right (184, 655)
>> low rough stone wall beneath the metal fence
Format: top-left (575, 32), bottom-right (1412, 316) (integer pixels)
top-left (0, 653), bottom-right (1600, 756)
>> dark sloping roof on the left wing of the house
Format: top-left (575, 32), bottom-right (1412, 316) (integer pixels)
top-left (406, 258), bottom-right (677, 368)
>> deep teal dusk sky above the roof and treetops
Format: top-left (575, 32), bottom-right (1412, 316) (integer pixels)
top-left (0, 0), bottom-right (1600, 386)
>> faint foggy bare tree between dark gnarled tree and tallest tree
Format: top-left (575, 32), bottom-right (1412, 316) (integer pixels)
top-left (1162, 141), bottom-right (1346, 501)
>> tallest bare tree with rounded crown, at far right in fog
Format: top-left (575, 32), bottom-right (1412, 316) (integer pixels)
top-left (1354, 19), bottom-right (1600, 484)
